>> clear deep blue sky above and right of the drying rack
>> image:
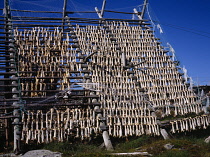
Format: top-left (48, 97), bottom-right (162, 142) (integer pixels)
top-left (0, 0), bottom-right (210, 85)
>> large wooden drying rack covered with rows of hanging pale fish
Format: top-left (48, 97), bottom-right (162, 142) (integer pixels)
top-left (0, 0), bottom-right (209, 153)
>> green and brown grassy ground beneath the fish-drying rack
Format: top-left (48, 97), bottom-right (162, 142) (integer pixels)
top-left (2, 128), bottom-right (210, 157)
